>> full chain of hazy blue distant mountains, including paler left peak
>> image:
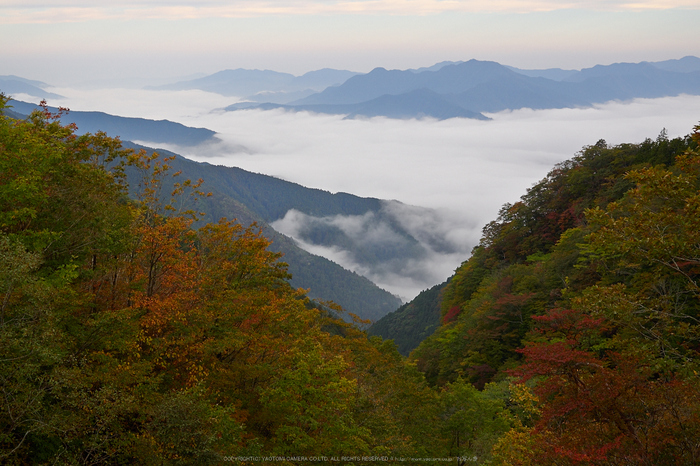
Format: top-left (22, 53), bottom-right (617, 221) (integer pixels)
top-left (152, 56), bottom-right (700, 120)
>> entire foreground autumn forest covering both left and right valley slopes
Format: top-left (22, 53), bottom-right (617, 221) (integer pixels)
top-left (0, 93), bottom-right (700, 465)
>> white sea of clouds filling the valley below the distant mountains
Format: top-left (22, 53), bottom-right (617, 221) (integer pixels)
top-left (32, 88), bottom-right (700, 300)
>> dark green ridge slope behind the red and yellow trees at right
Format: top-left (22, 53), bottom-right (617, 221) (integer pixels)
top-left (413, 128), bottom-right (690, 385)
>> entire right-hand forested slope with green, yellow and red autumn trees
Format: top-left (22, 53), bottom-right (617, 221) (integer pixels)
top-left (410, 127), bottom-right (700, 465)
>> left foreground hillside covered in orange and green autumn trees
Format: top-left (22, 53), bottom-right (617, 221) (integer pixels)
top-left (0, 98), bottom-right (532, 464)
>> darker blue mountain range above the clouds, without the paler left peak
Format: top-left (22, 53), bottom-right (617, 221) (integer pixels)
top-left (264, 57), bottom-right (700, 119)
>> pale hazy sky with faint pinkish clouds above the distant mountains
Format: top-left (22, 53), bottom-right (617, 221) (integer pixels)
top-left (0, 0), bottom-right (700, 85)
